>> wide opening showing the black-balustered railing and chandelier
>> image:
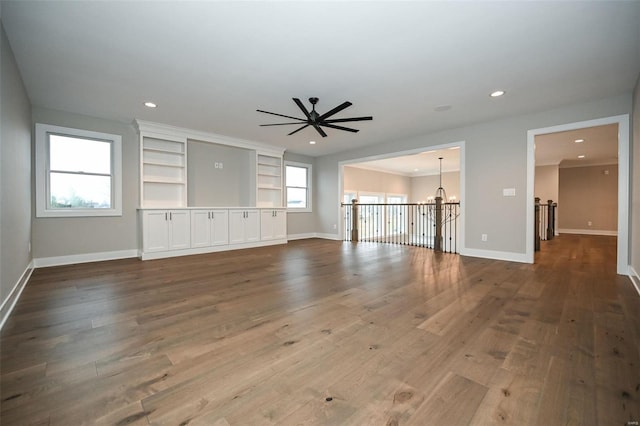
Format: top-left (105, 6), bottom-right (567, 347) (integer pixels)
top-left (339, 142), bottom-right (464, 253)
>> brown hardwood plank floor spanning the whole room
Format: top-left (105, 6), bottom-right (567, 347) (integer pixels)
top-left (0, 235), bottom-right (640, 426)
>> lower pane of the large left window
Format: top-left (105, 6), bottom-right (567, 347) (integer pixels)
top-left (50, 173), bottom-right (111, 209)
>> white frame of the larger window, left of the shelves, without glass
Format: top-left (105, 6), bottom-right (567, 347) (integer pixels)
top-left (35, 123), bottom-right (122, 217)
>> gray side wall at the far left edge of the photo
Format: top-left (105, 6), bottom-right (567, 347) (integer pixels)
top-left (0, 22), bottom-right (31, 303)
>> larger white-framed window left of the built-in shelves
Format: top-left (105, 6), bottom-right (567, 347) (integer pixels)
top-left (36, 124), bottom-right (122, 217)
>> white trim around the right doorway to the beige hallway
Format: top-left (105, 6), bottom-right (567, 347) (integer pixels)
top-left (525, 114), bottom-right (631, 275)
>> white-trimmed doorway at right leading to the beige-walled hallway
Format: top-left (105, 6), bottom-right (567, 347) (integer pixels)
top-left (527, 115), bottom-right (629, 275)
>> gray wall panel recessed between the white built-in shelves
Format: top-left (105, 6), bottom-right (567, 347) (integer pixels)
top-left (187, 140), bottom-right (256, 207)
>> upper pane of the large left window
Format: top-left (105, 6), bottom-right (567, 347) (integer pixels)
top-left (49, 134), bottom-right (111, 175)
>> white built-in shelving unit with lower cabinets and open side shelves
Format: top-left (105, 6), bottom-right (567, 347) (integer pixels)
top-left (135, 120), bottom-right (287, 259)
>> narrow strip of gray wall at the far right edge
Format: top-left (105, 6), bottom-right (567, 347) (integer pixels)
top-left (629, 75), bottom-right (640, 274)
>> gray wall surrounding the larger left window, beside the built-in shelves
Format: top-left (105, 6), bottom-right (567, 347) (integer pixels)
top-left (32, 107), bottom-right (140, 259)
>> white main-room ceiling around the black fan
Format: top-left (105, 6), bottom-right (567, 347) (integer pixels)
top-left (1, 1), bottom-right (640, 156)
